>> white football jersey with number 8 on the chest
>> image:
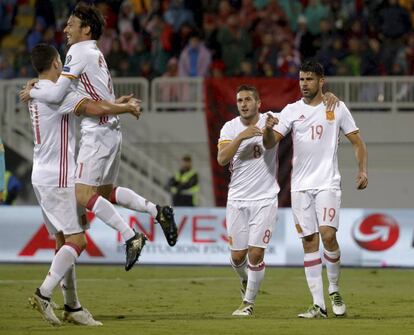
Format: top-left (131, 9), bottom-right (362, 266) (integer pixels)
top-left (218, 112), bottom-right (279, 200)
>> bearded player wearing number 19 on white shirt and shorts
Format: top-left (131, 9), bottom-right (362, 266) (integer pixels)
top-left (263, 61), bottom-right (368, 318)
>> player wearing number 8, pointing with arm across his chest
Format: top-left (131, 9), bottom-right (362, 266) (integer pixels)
top-left (217, 85), bottom-right (279, 316)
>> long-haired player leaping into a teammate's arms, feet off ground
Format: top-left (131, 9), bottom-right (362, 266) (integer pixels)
top-left (21, 2), bottom-right (177, 271)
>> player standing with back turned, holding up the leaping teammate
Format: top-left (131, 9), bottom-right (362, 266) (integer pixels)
top-left (29, 44), bottom-right (140, 326)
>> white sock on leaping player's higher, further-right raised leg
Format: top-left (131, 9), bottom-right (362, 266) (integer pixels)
top-left (111, 186), bottom-right (157, 218)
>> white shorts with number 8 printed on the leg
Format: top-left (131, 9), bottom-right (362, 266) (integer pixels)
top-left (226, 197), bottom-right (278, 250)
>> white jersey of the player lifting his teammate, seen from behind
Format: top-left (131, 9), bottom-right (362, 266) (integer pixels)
top-left (28, 80), bottom-right (85, 187)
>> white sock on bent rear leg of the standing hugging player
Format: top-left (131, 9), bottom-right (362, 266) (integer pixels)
top-left (39, 244), bottom-right (80, 298)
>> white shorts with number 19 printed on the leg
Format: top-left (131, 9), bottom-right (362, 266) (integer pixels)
top-left (291, 189), bottom-right (341, 237)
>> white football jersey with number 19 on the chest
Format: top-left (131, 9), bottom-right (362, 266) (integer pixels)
top-left (274, 100), bottom-right (358, 191)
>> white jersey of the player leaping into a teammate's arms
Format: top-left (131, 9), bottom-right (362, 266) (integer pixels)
top-left (62, 40), bottom-right (119, 130)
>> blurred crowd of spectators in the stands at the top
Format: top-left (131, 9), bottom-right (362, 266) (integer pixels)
top-left (0, 0), bottom-right (414, 79)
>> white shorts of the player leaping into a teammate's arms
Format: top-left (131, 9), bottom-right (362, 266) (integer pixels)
top-left (75, 128), bottom-right (122, 186)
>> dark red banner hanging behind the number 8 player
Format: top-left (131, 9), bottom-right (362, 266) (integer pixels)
top-left (204, 78), bottom-right (300, 207)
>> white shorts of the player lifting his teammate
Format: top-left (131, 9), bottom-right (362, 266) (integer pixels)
top-left (33, 185), bottom-right (89, 235)
